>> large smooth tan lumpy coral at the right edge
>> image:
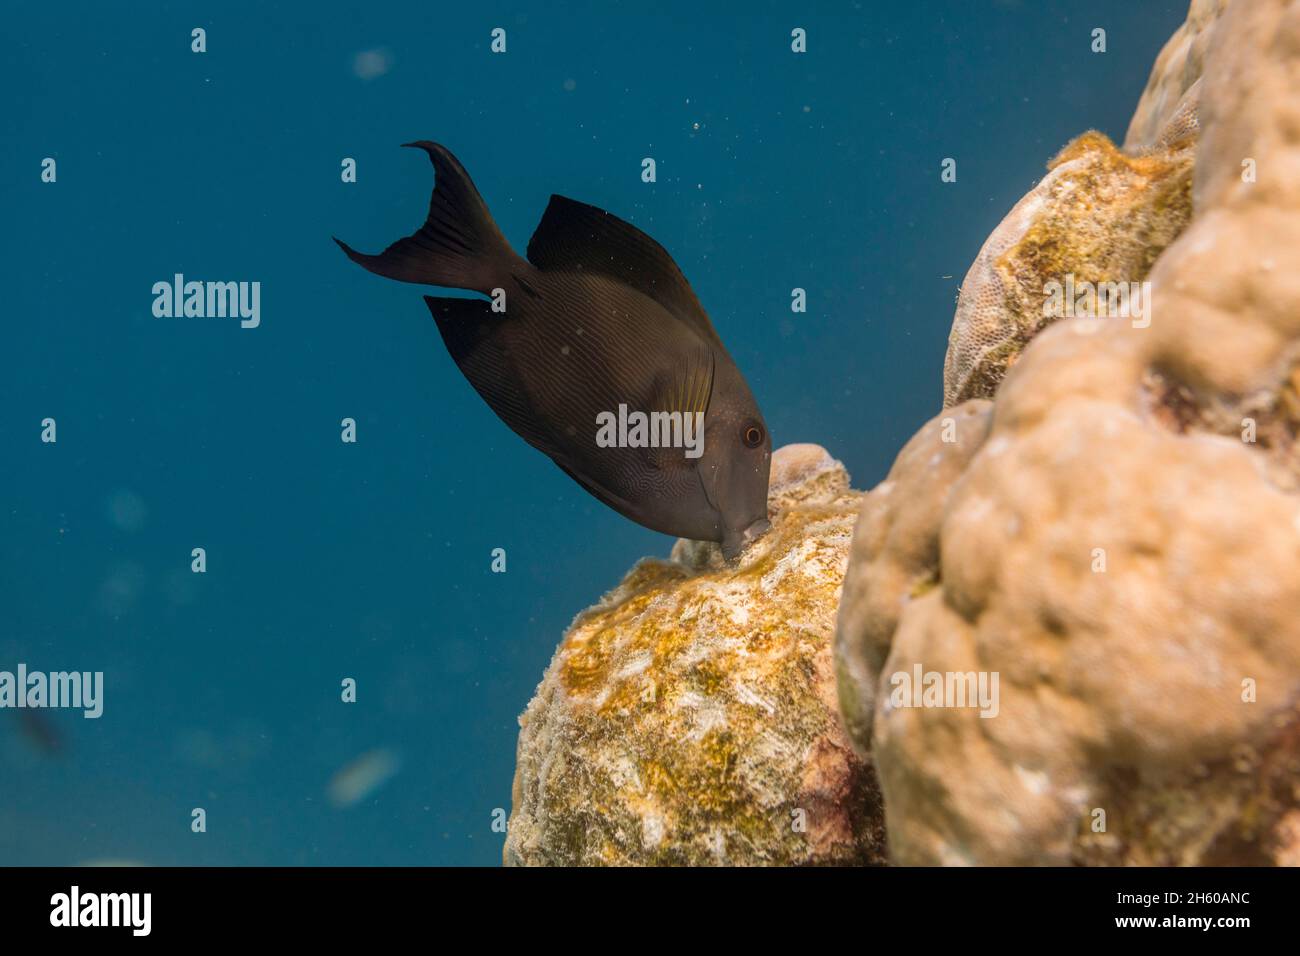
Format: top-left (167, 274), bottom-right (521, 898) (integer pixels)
top-left (836, 0), bottom-right (1300, 865)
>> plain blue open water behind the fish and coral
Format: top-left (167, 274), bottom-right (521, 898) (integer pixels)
top-left (0, 0), bottom-right (1187, 864)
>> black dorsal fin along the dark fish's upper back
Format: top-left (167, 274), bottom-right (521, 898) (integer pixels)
top-left (528, 195), bottom-right (722, 346)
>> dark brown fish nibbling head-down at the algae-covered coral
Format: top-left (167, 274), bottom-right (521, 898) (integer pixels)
top-left (335, 142), bottom-right (772, 558)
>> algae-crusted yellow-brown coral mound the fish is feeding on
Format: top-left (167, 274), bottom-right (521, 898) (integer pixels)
top-left (504, 445), bottom-right (885, 865)
